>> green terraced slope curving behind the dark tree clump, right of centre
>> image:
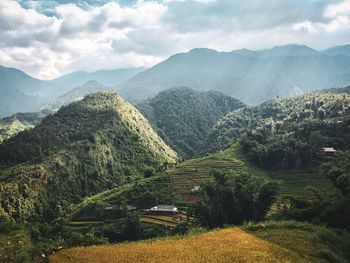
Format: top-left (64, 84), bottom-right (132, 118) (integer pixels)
top-left (168, 144), bottom-right (333, 199)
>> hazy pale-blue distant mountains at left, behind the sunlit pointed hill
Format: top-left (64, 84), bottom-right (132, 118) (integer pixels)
top-left (0, 65), bottom-right (143, 117)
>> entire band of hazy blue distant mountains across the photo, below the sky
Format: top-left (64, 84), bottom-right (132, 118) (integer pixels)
top-left (0, 45), bottom-right (350, 116)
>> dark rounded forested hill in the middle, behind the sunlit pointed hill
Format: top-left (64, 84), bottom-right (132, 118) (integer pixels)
top-left (137, 87), bottom-right (244, 158)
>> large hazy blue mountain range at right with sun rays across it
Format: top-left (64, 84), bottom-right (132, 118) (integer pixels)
top-left (117, 45), bottom-right (350, 104)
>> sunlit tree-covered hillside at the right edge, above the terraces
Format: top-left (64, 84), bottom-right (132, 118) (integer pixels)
top-left (208, 88), bottom-right (350, 168)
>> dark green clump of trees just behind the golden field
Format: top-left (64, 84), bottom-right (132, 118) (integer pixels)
top-left (193, 171), bottom-right (277, 228)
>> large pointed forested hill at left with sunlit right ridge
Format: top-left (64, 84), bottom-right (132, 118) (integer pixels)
top-left (0, 93), bottom-right (177, 221)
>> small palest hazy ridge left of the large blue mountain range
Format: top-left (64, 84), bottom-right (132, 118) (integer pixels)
top-left (50, 68), bottom-right (144, 91)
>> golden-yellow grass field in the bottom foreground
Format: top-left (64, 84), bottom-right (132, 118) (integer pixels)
top-left (50, 228), bottom-right (310, 263)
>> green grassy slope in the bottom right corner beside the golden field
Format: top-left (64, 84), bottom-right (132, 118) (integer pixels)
top-left (243, 221), bottom-right (350, 262)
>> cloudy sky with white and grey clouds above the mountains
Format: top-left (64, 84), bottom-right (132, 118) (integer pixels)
top-left (0, 0), bottom-right (350, 79)
